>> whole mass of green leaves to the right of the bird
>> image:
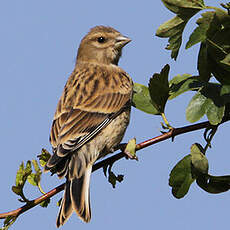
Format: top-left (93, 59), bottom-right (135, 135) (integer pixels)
top-left (133, 0), bottom-right (230, 198)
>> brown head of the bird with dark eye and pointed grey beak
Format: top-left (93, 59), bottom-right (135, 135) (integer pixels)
top-left (77, 26), bottom-right (131, 65)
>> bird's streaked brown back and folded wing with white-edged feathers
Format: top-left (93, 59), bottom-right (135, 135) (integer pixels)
top-left (50, 65), bottom-right (132, 157)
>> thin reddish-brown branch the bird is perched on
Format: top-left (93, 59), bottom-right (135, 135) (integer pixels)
top-left (0, 117), bottom-right (230, 219)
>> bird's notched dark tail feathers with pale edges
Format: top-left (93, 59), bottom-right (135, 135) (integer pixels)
top-left (56, 165), bottom-right (92, 227)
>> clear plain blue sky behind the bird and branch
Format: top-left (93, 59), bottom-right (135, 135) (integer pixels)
top-left (0, 0), bottom-right (230, 230)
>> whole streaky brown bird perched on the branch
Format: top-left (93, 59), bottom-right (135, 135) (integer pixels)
top-left (44, 26), bottom-right (133, 227)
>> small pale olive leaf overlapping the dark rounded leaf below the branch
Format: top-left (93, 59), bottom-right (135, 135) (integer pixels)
top-left (190, 143), bottom-right (208, 176)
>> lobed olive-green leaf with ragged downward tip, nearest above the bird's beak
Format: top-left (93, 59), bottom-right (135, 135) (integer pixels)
top-left (156, 16), bottom-right (188, 60)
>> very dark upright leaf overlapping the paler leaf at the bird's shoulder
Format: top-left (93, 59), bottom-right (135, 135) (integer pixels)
top-left (149, 65), bottom-right (170, 113)
